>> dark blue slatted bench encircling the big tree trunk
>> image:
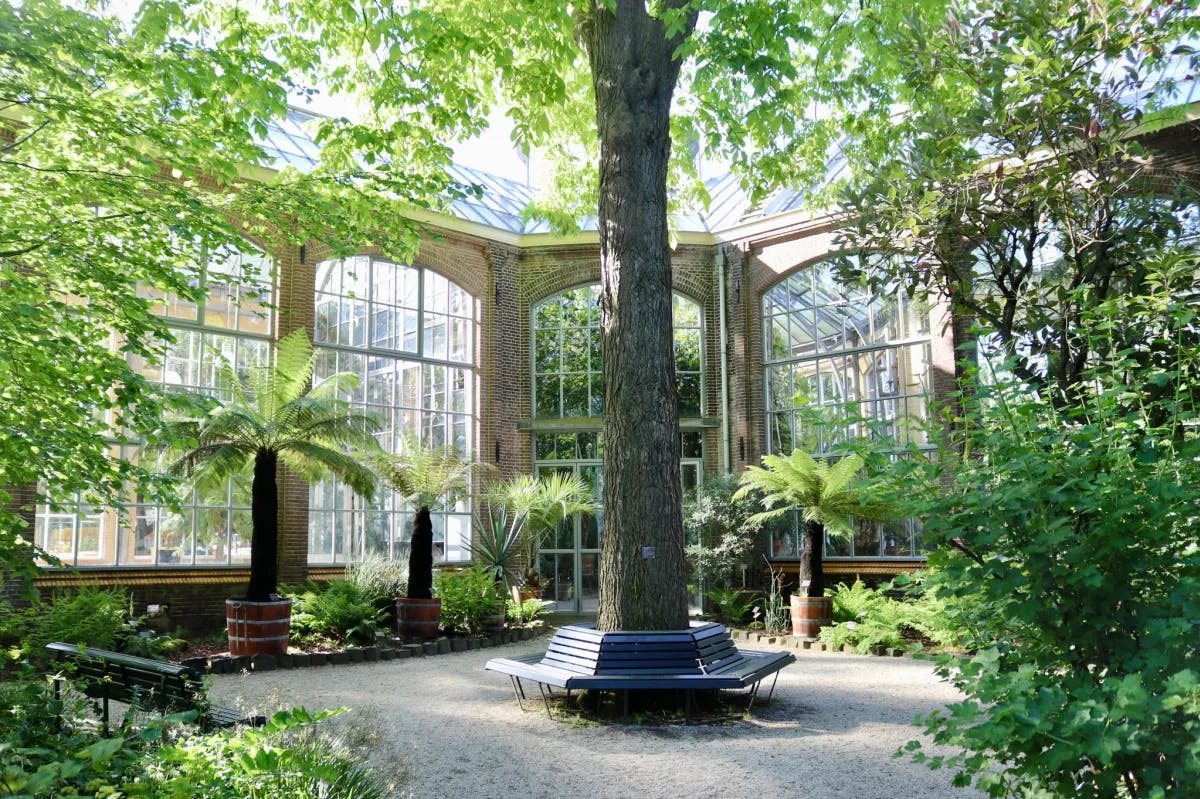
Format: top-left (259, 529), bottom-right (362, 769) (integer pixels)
top-left (485, 623), bottom-right (796, 714)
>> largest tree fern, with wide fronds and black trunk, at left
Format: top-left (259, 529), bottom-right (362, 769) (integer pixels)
top-left (163, 330), bottom-right (379, 602)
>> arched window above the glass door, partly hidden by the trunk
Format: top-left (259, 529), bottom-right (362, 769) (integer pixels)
top-left (533, 286), bottom-right (703, 419)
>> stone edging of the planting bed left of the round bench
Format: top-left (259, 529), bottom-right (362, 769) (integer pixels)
top-left (199, 626), bottom-right (550, 674)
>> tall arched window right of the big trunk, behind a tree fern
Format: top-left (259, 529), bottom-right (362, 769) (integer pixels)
top-left (762, 257), bottom-right (931, 558)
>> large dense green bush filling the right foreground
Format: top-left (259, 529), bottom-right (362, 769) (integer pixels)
top-left (897, 260), bottom-right (1200, 798)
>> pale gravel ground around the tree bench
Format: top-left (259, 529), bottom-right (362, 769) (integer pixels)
top-left (211, 638), bottom-right (982, 799)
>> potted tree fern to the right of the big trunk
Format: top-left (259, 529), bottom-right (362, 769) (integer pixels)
top-left (733, 450), bottom-right (889, 597)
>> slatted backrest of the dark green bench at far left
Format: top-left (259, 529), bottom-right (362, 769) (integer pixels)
top-left (46, 642), bottom-right (204, 710)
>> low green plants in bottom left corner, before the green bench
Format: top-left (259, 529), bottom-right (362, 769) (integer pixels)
top-left (0, 669), bottom-right (395, 799)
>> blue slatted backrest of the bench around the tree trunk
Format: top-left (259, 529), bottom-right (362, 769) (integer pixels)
top-left (541, 624), bottom-right (743, 675)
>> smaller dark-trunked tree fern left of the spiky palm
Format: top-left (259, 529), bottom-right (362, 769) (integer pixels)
top-left (376, 435), bottom-right (475, 600)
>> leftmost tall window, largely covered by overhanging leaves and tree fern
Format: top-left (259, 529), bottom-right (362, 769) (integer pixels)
top-left (36, 250), bottom-right (275, 566)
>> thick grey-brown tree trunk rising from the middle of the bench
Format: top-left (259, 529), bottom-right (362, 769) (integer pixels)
top-left (581, 0), bottom-right (695, 630)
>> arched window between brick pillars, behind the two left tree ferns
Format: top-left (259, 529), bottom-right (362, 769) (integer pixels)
top-left (308, 256), bottom-right (475, 564)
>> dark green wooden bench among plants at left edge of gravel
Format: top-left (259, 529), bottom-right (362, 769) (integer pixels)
top-left (46, 642), bottom-right (266, 735)
